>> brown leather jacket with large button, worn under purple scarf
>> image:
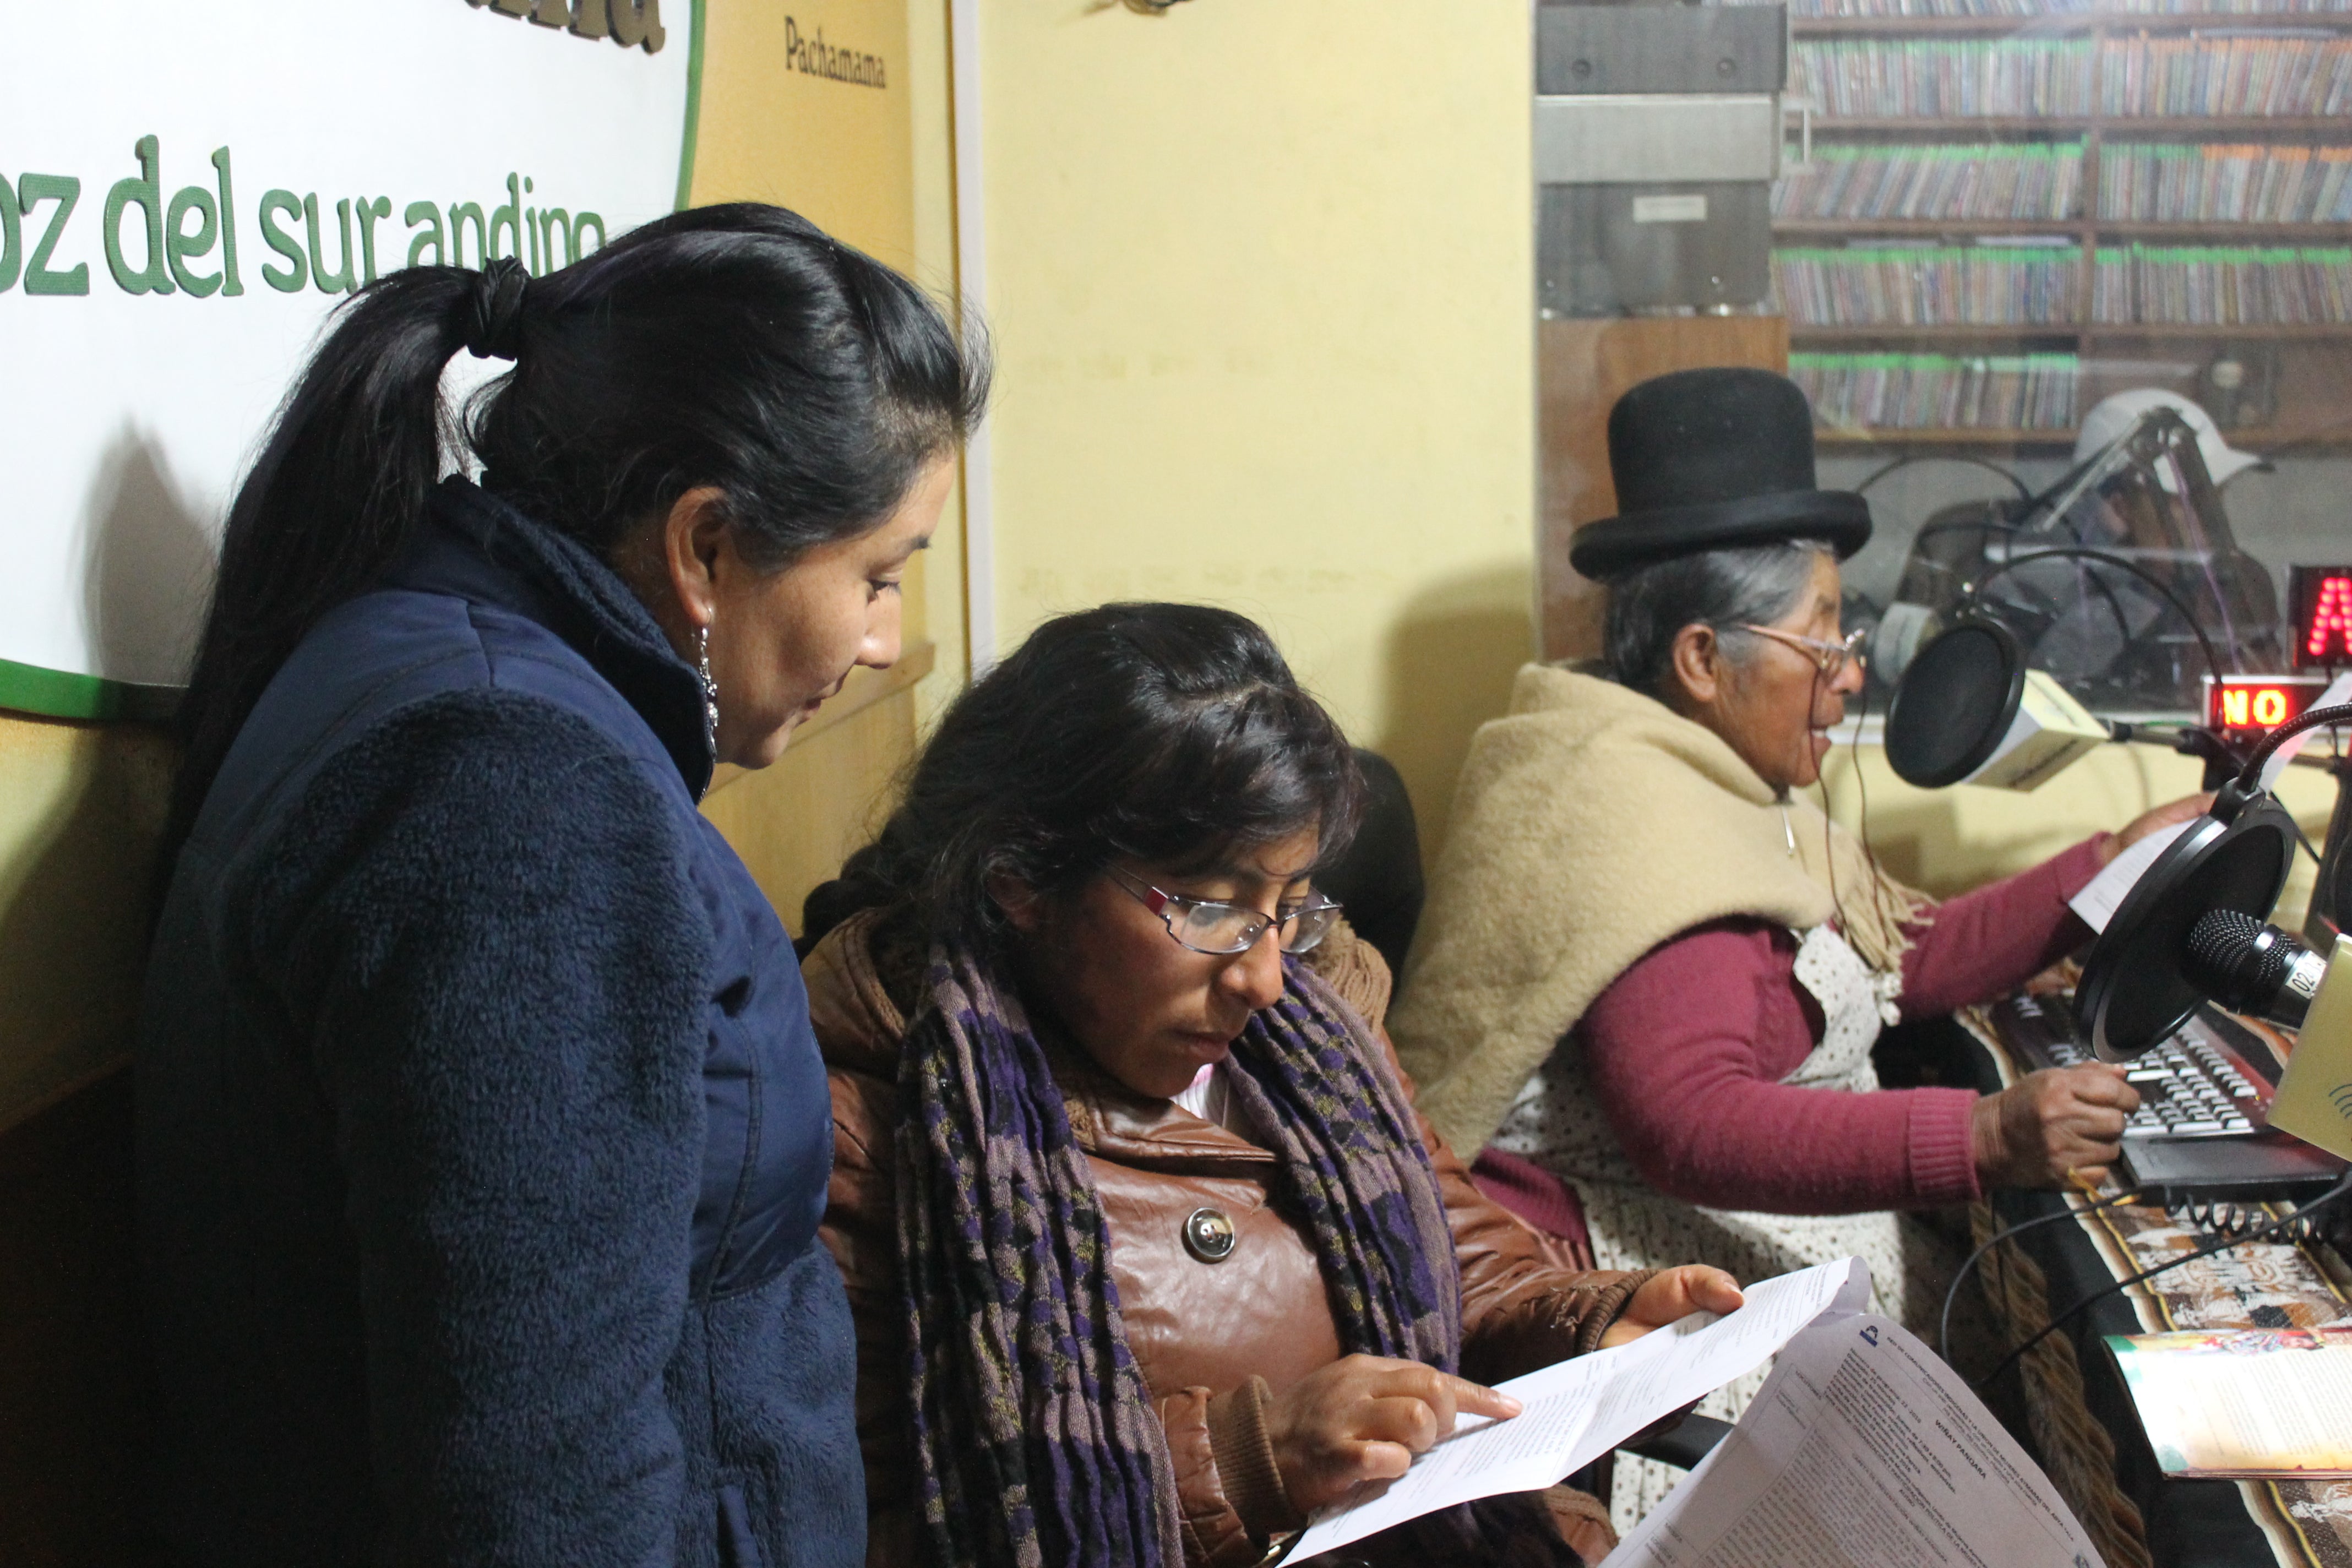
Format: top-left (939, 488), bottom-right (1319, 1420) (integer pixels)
top-left (802, 917), bottom-right (1649, 1568)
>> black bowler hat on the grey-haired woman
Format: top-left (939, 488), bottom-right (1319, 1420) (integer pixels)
top-left (1569, 367), bottom-right (1870, 578)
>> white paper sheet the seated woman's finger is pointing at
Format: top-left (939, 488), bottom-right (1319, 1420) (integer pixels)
top-left (1289, 1257), bottom-right (1870, 1561)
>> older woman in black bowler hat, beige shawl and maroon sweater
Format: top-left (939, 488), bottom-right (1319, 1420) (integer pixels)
top-left (1395, 369), bottom-right (2199, 1521)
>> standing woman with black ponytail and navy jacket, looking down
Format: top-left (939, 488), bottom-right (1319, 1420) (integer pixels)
top-left (139, 207), bottom-right (986, 1568)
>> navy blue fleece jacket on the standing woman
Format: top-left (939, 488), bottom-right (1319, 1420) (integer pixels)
top-left (137, 480), bottom-right (865, 1568)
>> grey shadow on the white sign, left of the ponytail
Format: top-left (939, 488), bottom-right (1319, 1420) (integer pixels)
top-left (83, 426), bottom-right (214, 687)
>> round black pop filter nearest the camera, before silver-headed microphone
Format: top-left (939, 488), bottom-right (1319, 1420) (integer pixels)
top-left (2075, 790), bottom-right (2295, 1063)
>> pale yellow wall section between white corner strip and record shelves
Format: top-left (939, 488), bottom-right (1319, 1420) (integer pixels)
top-left (981, 0), bottom-right (1536, 846)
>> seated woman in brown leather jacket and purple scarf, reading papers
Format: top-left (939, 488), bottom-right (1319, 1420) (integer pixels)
top-left (804, 604), bottom-right (1738, 1568)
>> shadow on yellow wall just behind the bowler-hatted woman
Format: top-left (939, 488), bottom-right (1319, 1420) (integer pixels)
top-left (1374, 564), bottom-right (1536, 865)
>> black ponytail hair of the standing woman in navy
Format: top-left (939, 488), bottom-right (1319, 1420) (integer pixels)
top-left (165, 202), bottom-right (988, 874)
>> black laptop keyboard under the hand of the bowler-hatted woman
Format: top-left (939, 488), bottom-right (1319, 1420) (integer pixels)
top-left (1992, 994), bottom-right (2269, 1138)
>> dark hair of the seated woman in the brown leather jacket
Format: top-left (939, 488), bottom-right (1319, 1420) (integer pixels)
top-left (799, 604), bottom-right (1364, 966)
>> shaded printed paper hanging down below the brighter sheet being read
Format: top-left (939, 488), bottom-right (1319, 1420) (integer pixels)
top-left (1602, 1314), bottom-right (2103, 1568)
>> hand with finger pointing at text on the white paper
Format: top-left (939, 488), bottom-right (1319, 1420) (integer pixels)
top-left (1265, 1357), bottom-right (1520, 1514)
